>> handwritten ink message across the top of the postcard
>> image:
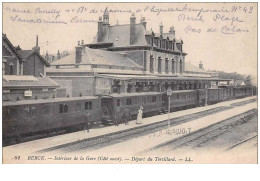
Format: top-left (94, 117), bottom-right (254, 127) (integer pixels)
top-left (4, 4), bottom-right (254, 35)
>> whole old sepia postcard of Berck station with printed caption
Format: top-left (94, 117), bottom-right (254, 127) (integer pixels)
top-left (1, 2), bottom-right (258, 164)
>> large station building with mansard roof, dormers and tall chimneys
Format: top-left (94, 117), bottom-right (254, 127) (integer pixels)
top-left (47, 12), bottom-right (226, 97)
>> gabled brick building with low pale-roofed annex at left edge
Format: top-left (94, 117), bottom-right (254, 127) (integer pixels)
top-left (2, 34), bottom-right (59, 101)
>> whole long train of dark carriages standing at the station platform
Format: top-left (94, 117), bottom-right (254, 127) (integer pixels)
top-left (2, 86), bottom-right (256, 144)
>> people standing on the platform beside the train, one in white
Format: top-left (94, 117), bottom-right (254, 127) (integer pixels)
top-left (82, 106), bottom-right (143, 132)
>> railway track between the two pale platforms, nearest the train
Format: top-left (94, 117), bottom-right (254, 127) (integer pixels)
top-left (39, 98), bottom-right (256, 153)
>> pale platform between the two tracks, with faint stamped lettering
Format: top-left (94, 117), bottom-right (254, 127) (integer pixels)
top-left (90, 102), bottom-right (257, 156)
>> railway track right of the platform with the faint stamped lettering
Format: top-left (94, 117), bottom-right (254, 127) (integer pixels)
top-left (146, 109), bottom-right (257, 151)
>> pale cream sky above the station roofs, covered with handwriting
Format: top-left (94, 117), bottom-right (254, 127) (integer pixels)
top-left (3, 3), bottom-right (257, 81)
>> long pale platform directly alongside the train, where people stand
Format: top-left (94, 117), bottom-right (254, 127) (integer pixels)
top-left (3, 96), bottom-right (257, 156)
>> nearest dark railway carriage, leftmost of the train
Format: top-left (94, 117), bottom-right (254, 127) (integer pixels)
top-left (3, 96), bottom-right (100, 141)
